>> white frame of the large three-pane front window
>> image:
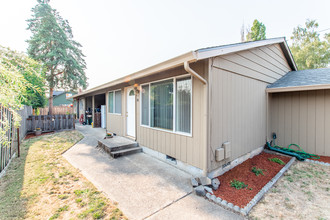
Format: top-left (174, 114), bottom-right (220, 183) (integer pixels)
top-left (139, 74), bottom-right (194, 137)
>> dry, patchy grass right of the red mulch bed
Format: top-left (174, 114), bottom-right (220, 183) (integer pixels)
top-left (249, 162), bottom-right (330, 219)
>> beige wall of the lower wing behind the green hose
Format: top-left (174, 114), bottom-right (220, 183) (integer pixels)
top-left (270, 90), bottom-right (330, 156)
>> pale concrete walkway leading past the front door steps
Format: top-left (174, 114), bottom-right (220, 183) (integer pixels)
top-left (63, 124), bottom-right (243, 219)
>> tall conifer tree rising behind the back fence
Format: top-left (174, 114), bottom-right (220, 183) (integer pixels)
top-left (27, 0), bottom-right (87, 114)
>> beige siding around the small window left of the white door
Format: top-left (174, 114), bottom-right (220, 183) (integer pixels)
top-left (106, 89), bottom-right (126, 136)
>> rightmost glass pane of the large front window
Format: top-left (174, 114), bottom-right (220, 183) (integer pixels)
top-left (175, 77), bottom-right (191, 133)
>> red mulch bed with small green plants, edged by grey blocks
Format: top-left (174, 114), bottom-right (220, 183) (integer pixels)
top-left (214, 152), bottom-right (291, 208)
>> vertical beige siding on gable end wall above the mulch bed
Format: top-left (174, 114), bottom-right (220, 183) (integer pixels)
top-left (209, 68), bottom-right (267, 170)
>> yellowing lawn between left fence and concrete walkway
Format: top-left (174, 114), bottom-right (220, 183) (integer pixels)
top-left (0, 131), bottom-right (125, 219)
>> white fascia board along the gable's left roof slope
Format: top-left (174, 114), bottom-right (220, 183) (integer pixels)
top-left (196, 37), bottom-right (285, 60)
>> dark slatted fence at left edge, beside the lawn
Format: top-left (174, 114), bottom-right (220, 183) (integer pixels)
top-left (0, 104), bottom-right (16, 174)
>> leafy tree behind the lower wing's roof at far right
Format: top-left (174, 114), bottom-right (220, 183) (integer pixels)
top-left (290, 20), bottom-right (330, 70)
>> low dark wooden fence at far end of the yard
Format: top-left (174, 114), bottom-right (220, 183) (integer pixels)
top-left (26, 114), bottom-right (75, 132)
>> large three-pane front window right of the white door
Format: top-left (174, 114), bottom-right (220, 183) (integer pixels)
top-left (141, 77), bottom-right (192, 134)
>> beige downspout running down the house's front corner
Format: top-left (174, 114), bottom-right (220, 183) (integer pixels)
top-left (183, 61), bottom-right (209, 176)
